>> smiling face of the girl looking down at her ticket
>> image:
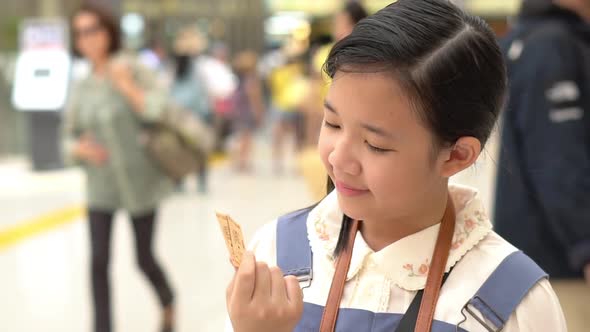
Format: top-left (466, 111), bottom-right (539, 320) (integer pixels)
top-left (319, 73), bottom-right (449, 220)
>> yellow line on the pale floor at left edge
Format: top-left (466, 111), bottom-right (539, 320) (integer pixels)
top-left (0, 206), bottom-right (86, 251)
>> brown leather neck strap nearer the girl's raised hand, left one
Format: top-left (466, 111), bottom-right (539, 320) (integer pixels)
top-left (320, 220), bottom-right (359, 332)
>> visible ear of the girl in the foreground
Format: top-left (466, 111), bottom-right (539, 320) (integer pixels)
top-left (440, 137), bottom-right (481, 178)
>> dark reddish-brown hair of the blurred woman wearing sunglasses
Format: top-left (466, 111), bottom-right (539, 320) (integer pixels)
top-left (70, 1), bottom-right (121, 56)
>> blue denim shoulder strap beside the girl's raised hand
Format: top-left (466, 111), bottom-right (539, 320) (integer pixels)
top-left (277, 208), bottom-right (313, 282)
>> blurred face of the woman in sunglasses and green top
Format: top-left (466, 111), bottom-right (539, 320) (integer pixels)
top-left (72, 12), bottom-right (110, 63)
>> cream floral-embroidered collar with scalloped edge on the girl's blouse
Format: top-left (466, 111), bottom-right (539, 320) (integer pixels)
top-left (307, 185), bottom-right (492, 291)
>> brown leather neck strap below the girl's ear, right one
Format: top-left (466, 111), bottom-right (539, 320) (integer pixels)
top-left (414, 195), bottom-right (455, 332)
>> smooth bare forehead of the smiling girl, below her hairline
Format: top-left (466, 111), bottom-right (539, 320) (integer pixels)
top-left (326, 72), bottom-right (418, 127)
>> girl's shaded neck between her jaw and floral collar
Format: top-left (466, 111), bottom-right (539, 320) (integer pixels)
top-left (360, 186), bottom-right (449, 252)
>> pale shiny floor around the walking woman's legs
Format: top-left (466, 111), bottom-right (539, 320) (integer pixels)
top-left (0, 143), bottom-right (313, 332)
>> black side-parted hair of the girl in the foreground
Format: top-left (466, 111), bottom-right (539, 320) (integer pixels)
top-left (324, 0), bottom-right (507, 255)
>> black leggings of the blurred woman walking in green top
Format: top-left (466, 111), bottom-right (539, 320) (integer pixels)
top-left (89, 210), bottom-right (173, 332)
